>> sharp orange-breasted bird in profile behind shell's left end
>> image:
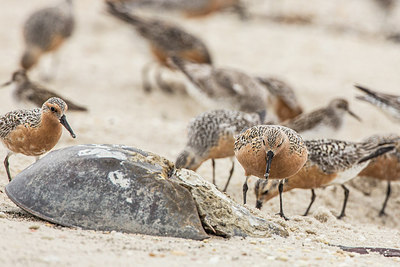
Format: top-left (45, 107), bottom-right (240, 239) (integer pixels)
top-left (0, 97), bottom-right (76, 181)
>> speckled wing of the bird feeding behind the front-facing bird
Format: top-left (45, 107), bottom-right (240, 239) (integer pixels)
top-left (304, 139), bottom-right (393, 173)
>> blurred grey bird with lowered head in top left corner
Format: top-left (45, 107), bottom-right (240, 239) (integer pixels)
top-left (21, 0), bottom-right (74, 70)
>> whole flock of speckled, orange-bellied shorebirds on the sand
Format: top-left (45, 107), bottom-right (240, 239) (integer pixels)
top-left (0, 0), bottom-right (400, 224)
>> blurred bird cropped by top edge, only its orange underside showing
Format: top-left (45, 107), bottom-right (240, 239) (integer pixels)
top-left (109, 0), bottom-right (248, 18)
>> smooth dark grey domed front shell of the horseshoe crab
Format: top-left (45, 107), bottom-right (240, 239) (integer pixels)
top-left (6, 145), bottom-right (208, 240)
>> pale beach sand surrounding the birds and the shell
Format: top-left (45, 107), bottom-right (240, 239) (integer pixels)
top-left (0, 0), bottom-right (400, 266)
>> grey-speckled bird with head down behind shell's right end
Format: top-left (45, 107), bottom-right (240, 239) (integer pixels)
top-left (175, 109), bottom-right (265, 192)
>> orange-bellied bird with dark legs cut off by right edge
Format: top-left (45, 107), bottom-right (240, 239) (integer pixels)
top-left (358, 134), bottom-right (400, 216)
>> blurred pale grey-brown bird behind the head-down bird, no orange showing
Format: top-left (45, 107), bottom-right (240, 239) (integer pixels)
top-left (171, 57), bottom-right (268, 112)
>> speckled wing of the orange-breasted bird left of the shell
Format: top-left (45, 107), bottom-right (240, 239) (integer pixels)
top-left (0, 108), bottom-right (41, 138)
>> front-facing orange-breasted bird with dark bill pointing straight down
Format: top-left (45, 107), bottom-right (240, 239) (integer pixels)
top-left (235, 125), bottom-right (308, 220)
